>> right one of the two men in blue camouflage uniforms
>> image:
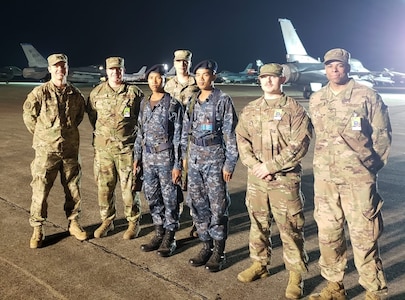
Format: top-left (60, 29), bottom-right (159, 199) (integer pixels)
top-left (182, 60), bottom-right (239, 272)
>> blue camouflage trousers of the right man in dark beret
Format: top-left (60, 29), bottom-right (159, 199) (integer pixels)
top-left (186, 161), bottom-right (231, 242)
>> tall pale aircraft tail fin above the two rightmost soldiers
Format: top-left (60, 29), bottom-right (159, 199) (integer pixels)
top-left (278, 19), bottom-right (319, 63)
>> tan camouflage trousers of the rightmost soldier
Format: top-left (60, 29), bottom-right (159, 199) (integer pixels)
top-left (314, 179), bottom-right (387, 291)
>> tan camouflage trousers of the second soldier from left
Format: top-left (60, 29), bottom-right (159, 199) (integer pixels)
top-left (94, 150), bottom-right (141, 222)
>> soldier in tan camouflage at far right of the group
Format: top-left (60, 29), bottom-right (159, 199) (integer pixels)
top-left (309, 49), bottom-right (392, 299)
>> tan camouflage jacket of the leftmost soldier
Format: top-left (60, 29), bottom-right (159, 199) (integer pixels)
top-left (23, 81), bottom-right (85, 155)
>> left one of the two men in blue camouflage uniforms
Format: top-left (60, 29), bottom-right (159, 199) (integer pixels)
top-left (134, 65), bottom-right (183, 257)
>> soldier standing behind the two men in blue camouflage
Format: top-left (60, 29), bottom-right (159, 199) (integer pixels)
top-left (165, 50), bottom-right (198, 237)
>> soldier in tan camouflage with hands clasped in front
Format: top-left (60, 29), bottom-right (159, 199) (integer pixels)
top-left (236, 63), bottom-right (312, 299)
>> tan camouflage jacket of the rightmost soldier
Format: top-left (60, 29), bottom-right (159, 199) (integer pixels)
top-left (309, 79), bottom-right (392, 182)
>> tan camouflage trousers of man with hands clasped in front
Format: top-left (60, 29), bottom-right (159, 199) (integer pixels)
top-left (246, 174), bottom-right (308, 273)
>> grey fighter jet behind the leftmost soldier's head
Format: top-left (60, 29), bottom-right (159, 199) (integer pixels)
top-left (20, 43), bottom-right (105, 84)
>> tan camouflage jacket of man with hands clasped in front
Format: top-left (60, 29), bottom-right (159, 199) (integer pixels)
top-left (236, 94), bottom-right (312, 174)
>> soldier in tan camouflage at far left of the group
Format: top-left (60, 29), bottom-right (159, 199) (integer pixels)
top-left (23, 54), bottom-right (87, 248)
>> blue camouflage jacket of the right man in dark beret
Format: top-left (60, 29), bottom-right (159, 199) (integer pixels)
top-left (181, 88), bottom-right (239, 172)
